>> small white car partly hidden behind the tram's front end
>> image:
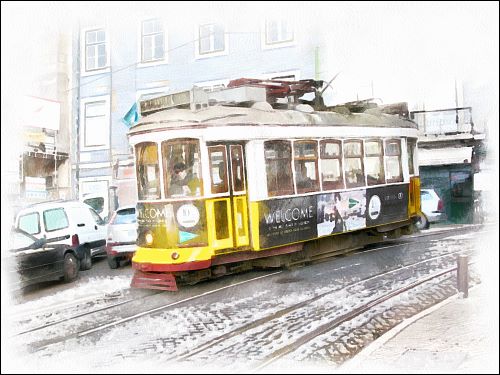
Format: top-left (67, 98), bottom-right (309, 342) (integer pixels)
top-left (106, 206), bottom-right (137, 269)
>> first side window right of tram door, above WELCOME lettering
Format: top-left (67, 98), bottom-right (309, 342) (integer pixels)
top-left (264, 141), bottom-right (294, 197)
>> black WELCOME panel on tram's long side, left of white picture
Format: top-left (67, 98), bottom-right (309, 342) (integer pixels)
top-left (259, 196), bottom-right (317, 248)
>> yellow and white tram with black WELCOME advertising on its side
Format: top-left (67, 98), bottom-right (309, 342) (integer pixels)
top-left (129, 80), bottom-right (420, 291)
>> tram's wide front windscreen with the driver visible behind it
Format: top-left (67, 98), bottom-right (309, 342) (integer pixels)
top-left (162, 138), bottom-right (203, 198)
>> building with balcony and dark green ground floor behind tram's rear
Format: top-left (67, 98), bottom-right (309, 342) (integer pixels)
top-left (411, 107), bottom-right (485, 224)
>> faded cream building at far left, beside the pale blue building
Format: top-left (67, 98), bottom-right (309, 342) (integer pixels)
top-left (2, 28), bottom-right (72, 220)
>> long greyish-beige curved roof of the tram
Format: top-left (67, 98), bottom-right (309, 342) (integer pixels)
top-left (129, 103), bottom-right (417, 135)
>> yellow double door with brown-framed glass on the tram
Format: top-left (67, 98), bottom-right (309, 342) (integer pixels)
top-left (207, 143), bottom-right (250, 248)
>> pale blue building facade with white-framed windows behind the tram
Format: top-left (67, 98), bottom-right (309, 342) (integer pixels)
top-left (72, 8), bottom-right (319, 216)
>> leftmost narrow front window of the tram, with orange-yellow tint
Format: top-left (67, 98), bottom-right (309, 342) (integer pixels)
top-left (135, 142), bottom-right (160, 200)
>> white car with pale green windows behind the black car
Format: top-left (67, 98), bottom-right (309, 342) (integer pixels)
top-left (15, 200), bottom-right (106, 270)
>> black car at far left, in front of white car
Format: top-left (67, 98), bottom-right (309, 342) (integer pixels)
top-left (3, 228), bottom-right (83, 290)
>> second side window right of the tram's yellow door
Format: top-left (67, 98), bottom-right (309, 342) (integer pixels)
top-left (293, 141), bottom-right (319, 193)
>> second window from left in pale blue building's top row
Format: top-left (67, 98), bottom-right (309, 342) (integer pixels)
top-left (141, 19), bottom-right (166, 63)
